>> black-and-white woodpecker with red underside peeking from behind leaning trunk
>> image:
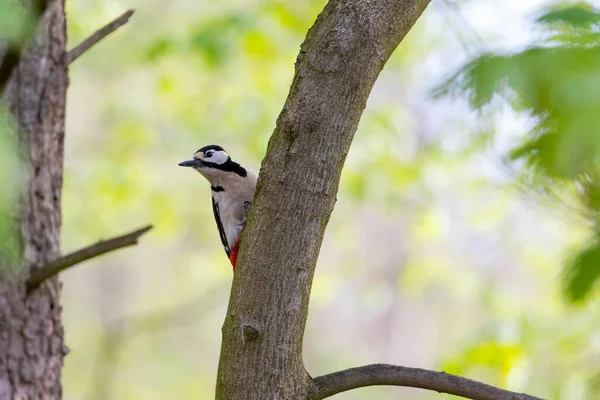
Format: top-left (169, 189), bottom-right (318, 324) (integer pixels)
top-left (179, 145), bottom-right (258, 271)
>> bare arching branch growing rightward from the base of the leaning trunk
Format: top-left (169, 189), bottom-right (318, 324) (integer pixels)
top-left (312, 364), bottom-right (541, 400)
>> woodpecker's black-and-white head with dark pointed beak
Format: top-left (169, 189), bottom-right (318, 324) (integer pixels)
top-left (179, 145), bottom-right (247, 184)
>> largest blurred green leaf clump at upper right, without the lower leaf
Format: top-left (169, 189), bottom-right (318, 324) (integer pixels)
top-left (438, 46), bottom-right (600, 179)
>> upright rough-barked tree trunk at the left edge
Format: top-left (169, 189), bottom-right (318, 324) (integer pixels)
top-left (0, 0), bottom-right (68, 399)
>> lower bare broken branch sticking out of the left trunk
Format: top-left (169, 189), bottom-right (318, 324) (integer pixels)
top-left (27, 225), bottom-right (152, 291)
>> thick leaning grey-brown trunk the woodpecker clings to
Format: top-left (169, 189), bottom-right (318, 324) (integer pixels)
top-left (216, 0), bottom-right (429, 400)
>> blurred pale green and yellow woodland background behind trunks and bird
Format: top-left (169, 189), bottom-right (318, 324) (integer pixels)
top-left (0, 0), bottom-right (600, 400)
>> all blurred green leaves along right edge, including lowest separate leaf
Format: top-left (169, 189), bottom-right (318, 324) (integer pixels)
top-left (435, 3), bottom-right (600, 300)
